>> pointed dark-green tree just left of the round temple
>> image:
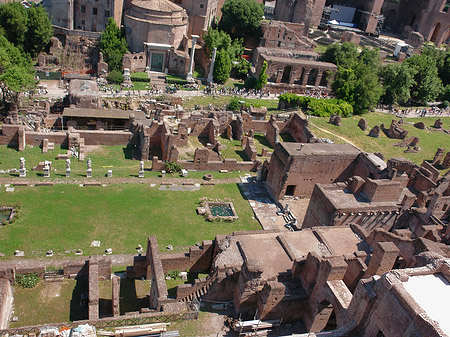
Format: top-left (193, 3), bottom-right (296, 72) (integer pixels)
top-left (100, 17), bottom-right (128, 71)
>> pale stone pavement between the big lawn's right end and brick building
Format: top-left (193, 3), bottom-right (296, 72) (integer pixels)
top-left (239, 181), bottom-right (287, 231)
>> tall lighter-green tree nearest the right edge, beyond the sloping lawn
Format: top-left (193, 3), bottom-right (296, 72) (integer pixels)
top-left (404, 53), bottom-right (443, 103)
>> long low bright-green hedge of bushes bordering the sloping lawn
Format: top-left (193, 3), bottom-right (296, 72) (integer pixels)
top-left (280, 93), bottom-right (353, 117)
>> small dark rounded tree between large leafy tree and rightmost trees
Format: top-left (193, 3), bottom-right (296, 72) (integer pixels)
top-left (380, 63), bottom-right (416, 104)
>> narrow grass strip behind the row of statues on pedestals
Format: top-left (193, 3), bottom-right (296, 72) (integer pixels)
top-left (0, 145), bottom-right (250, 181)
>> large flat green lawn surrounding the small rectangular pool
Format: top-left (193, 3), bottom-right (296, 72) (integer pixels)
top-left (0, 184), bottom-right (260, 258)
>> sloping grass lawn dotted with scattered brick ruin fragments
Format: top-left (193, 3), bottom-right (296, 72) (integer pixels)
top-left (309, 112), bottom-right (450, 171)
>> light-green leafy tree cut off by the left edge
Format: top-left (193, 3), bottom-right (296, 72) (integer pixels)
top-left (0, 35), bottom-right (36, 105)
